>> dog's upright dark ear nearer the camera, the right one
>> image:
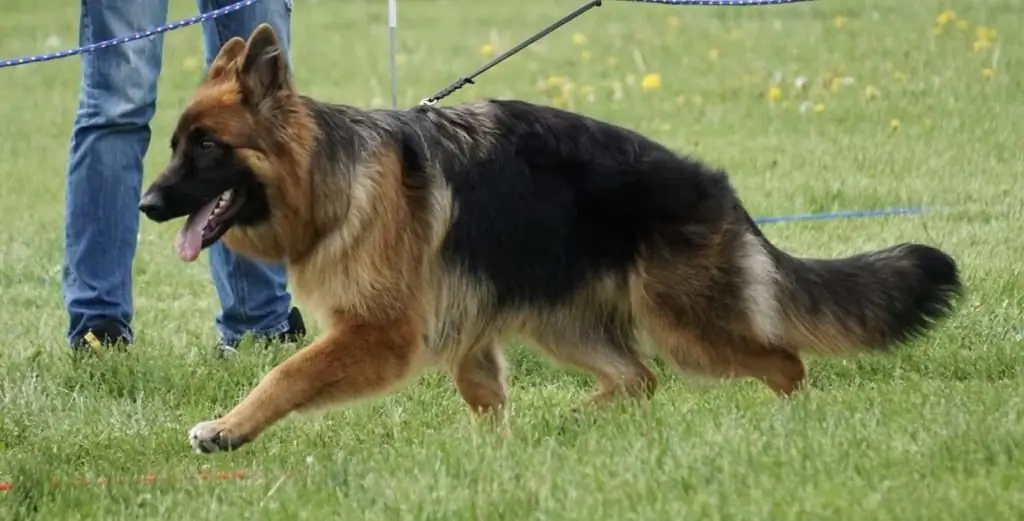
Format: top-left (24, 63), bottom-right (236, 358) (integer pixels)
top-left (239, 24), bottom-right (291, 104)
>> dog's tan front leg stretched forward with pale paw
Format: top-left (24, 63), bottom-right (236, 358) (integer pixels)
top-left (188, 318), bottom-right (422, 452)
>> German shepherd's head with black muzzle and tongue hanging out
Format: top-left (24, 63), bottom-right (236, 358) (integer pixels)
top-left (139, 24), bottom-right (296, 261)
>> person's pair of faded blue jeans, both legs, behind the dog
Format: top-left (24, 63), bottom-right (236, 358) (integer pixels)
top-left (62, 0), bottom-right (292, 345)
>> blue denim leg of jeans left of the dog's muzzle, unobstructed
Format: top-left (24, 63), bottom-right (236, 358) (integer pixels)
top-left (61, 0), bottom-right (167, 341)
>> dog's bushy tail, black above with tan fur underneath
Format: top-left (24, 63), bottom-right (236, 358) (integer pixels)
top-left (752, 213), bottom-right (963, 355)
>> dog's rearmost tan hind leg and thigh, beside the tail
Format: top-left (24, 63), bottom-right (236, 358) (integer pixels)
top-left (632, 245), bottom-right (806, 395)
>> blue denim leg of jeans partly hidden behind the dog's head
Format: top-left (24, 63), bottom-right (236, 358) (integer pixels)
top-left (198, 0), bottom-right (292, 346)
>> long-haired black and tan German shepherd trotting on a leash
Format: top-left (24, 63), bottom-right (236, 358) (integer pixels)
top-left (139, 25), bottom-right (963, 452)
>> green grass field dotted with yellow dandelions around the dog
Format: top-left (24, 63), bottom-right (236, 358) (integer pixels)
top-left (0, 0), bottom-right (1024, 521)
